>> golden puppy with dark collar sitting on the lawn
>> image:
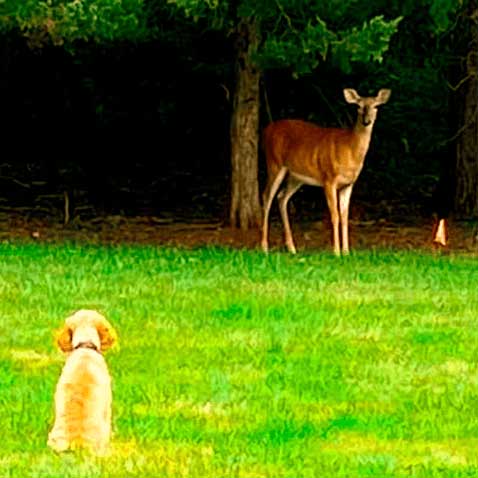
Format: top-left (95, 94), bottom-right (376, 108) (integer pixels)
top-left (48, 310), bottom-right (118, 455)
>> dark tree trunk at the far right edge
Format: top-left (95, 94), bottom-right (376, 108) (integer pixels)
top-left (455, 0), bottom-right (478, 218)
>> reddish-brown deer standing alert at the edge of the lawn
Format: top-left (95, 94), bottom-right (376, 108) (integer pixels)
top-left (261, 88), bottom-right (391, 256)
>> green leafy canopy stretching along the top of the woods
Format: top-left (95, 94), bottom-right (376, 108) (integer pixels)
top-left (0, 0), bottom-right (465, 76)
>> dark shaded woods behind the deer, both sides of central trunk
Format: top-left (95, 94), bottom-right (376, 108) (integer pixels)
top-left (0, 9), bottom-right (459, 221)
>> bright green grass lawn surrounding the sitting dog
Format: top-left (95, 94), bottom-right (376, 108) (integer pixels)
top-left (0, 243), bottom-right (478, 478)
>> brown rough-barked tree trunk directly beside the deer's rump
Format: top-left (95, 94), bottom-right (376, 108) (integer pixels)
top-left (230, 18), bottom-right (261, 230)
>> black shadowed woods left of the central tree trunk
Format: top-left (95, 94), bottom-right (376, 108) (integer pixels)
top-left (0, 34), bottom-right (233, 215)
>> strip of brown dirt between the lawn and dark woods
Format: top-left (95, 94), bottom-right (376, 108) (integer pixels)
top-left (0, 214), bottom-right (478, 256)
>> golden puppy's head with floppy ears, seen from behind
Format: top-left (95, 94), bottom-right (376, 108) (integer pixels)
top-left (56, 310), bottom-right (118, 352)
